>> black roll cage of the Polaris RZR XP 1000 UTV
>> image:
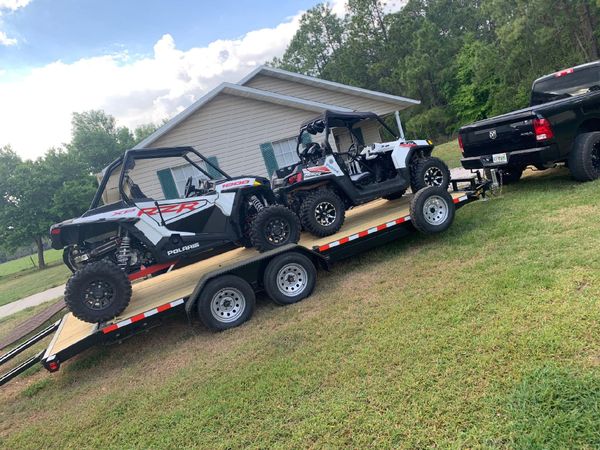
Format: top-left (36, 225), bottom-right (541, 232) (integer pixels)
top-left (90, 147), bottom-right (231, 209)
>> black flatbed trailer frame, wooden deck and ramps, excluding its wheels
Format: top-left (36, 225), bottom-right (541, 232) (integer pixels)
top-left (0, 178), bottom-right (487, 386)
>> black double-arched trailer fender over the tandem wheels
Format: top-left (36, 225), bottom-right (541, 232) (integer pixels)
top-left (185, 244), bottom-right (329, 321)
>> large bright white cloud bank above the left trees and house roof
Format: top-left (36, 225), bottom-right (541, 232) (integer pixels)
top-left (0, 12), bottom-right (300, 158)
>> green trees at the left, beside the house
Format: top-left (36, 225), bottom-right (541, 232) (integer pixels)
top-left (0, 111), bottom-right (156, 269)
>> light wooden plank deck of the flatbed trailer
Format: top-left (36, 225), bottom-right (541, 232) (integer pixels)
top-left (45, 191), bottom-right (466, 357)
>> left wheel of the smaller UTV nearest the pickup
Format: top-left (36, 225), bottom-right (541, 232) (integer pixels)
top-left (300, 189), bottom-right (346, 237)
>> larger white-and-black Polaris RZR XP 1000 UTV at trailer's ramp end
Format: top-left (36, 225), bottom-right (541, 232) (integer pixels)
top-left (50, 147), bottom-right (300, 323)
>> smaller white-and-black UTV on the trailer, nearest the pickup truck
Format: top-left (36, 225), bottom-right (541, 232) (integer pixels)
top-left (271, 111), bottom-right (450, 236)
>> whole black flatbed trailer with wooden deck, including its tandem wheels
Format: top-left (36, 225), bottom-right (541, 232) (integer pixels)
top-left (0, 178), bottom-right (487, 385)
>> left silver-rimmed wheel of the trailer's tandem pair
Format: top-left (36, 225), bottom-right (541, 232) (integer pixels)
top-left (196, 275), bottom-right (256, 331)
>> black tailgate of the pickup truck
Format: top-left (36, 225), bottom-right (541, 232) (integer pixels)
top-left (460, 109), bottom-right (536, 158)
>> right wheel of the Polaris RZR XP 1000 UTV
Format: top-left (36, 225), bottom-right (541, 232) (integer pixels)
top-left (250, 206), bottom-right (300, 252)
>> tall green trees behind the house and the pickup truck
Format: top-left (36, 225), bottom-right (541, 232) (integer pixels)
top-left (272, 0), bottom-right (600, 140)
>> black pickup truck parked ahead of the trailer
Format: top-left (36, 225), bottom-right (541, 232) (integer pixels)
top-left (458, 61), bottom-right (600, 183)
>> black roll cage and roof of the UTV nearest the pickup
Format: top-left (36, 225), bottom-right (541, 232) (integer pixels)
top-left (296, 109), bottom-right (399, 157)
